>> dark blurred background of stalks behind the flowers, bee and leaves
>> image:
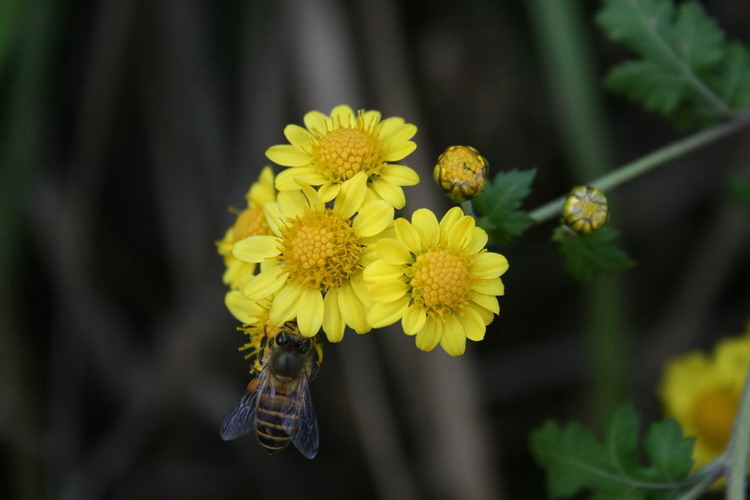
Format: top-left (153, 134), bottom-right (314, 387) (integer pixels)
top-left (0, 0), bottom-right (750, 499)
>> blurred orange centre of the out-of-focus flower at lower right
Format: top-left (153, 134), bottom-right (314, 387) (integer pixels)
top-left (693, 389), bottom-right (739, 450)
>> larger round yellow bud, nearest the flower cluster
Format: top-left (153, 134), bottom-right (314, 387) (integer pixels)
top-left (432, 146), bottom-right (489, 203)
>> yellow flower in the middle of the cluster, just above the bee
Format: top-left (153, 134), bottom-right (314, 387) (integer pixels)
top-left (233, 172), bottom-right (394, 342)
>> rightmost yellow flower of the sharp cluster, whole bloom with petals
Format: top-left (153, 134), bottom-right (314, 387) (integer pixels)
top-left (364, 207), bottom-right (508, 356)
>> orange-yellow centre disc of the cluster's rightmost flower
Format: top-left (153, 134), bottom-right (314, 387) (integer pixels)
top-left (411, 250), bottom-right (471, 316)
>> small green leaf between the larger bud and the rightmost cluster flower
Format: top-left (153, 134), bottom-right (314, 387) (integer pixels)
top-left (472, 169), bottom-right (536, 245)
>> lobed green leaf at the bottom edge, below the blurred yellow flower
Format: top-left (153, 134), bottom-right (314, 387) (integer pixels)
top-left (531, 405), bottom-right (694, 500)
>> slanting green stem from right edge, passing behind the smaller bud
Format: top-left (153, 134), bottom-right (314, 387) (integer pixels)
top-left (529, 113), bottom-right (750, 223)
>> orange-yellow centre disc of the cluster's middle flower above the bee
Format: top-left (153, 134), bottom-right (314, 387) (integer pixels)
top-left (281, 208), bottom-right (362, 292)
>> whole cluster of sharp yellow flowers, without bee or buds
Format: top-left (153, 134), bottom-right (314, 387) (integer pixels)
top-left (218, 106), bottom-right (508, 356)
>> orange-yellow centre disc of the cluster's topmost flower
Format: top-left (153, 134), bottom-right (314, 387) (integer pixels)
top-left (313, 127), bottom-right (382, 182)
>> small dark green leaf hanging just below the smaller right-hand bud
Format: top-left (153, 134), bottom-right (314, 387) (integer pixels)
top-left (552, 226), bottom-right (635, 282)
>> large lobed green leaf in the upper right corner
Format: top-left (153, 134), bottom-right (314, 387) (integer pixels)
top-left (596, 0), bottom-right (750, 126)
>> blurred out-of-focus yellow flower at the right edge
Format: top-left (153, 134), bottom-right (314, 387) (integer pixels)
top-left (659, 333), bottom-right (750, 469)
